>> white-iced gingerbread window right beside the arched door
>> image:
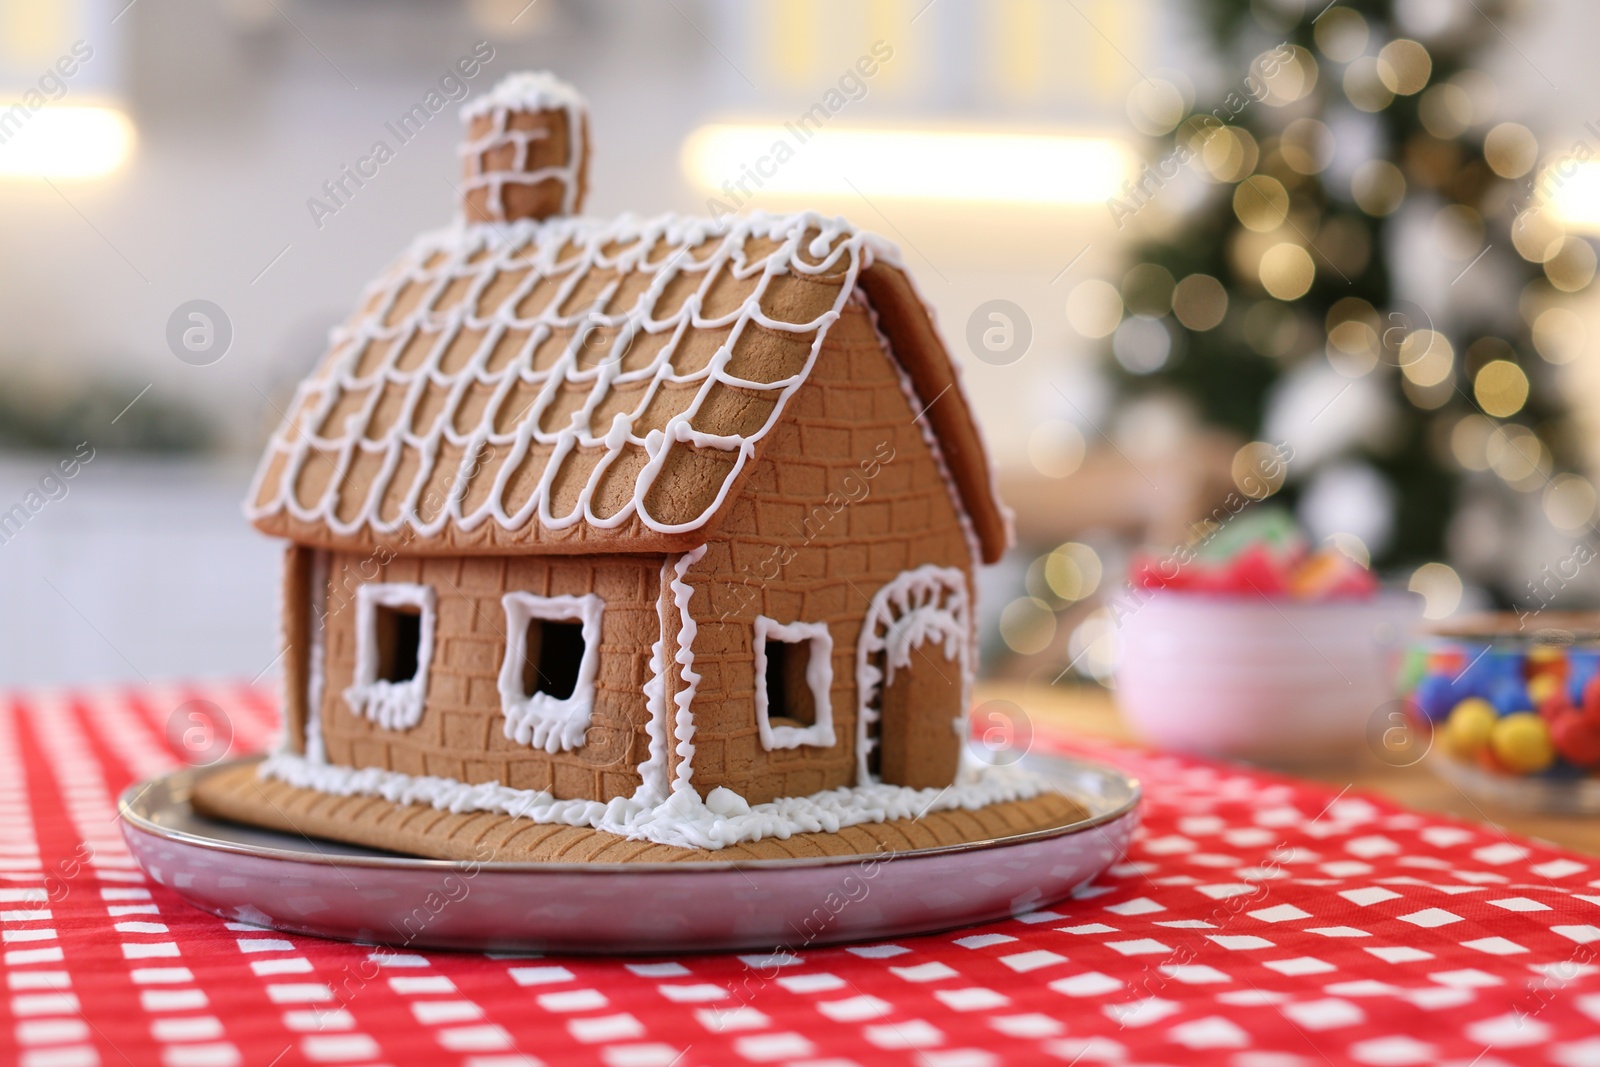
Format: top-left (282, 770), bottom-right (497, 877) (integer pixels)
top-left (755, 616), bottom-right (834, 750)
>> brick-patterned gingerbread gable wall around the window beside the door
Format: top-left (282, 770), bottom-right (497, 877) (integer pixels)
top-left (667, 302), bottom-right (971, 803)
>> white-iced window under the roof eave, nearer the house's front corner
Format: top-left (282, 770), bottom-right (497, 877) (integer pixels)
top-left (499, 592), bottom-right (605, 752)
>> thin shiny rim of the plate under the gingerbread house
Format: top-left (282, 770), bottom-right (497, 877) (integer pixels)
top-left (117, 753), bottom-right (1144, 875)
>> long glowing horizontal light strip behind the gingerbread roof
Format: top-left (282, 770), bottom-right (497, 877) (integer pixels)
top-left (682, 125), bottom-right (1133, 208)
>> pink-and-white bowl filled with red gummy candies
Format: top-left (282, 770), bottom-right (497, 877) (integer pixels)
top-left (1114, 512), bottom-right (1421, 766)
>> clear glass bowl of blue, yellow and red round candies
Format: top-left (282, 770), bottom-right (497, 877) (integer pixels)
top-left (1405, 613), bottom-right (1600, 813)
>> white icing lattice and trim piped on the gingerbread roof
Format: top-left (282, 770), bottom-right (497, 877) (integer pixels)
top-left (243, 211), bottom-right (1010, 550)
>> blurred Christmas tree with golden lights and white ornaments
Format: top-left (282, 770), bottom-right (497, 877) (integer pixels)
top-left (1100, 0), bottom-right (1595, 603)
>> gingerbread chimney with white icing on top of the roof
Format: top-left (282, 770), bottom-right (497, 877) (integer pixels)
top-left (461, 70), bottom-right (589, 222)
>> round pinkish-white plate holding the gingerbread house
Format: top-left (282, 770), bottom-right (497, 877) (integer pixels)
top-left (118, 758), bottom-right (1139, 953)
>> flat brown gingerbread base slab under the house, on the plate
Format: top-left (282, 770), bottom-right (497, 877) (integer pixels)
top-left (194, 761), bottom-right (1088, 864)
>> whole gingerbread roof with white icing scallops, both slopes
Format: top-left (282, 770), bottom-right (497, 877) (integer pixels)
top-left (246, 214), bottom-right (1008, 558)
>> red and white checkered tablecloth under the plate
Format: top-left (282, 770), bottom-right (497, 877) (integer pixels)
top-left (0, 685), bottom-right (1600, 1067)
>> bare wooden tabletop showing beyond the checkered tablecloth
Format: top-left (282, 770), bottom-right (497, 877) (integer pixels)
top-left (978, 685), bottom-right (1600, 856)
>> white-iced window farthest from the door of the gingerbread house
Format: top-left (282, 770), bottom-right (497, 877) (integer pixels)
top-left (344, 582), bottom-right (437, 729)
